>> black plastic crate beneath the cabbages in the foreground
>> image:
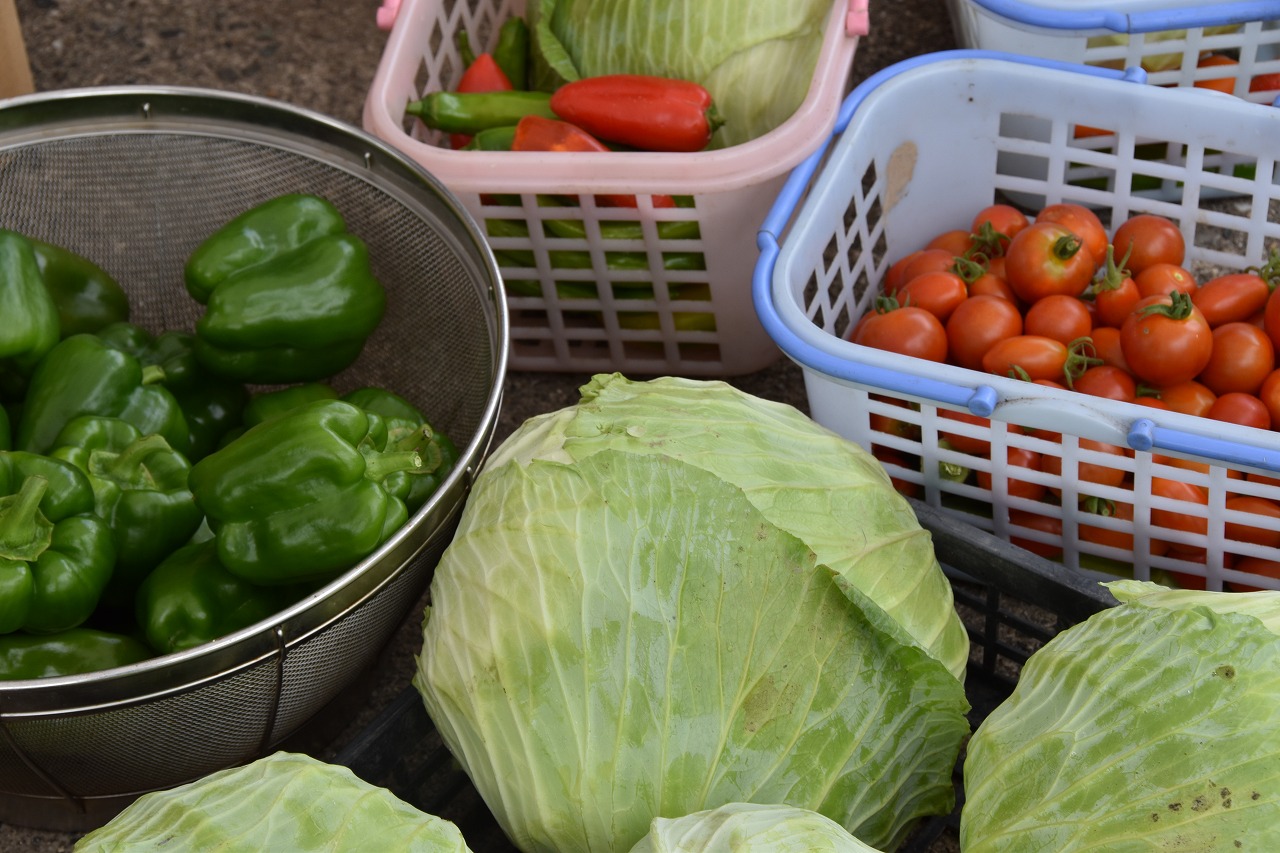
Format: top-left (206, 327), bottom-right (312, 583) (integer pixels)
top-left (335, 501), bottom-right (1115, 853)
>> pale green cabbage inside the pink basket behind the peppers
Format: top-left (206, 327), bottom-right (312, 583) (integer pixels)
top-left (529, 0), bottom-right (831, 147)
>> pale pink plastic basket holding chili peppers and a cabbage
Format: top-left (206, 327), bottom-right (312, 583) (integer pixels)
top-left (364, 0), bottom-right (867, 377)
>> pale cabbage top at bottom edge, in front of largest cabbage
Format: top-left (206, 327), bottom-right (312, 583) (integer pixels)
top-left (631, 803), bottom-right (877, 853)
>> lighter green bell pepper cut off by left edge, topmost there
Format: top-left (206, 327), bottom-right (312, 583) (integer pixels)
top-left (0, 229), bottom-right (59, 398)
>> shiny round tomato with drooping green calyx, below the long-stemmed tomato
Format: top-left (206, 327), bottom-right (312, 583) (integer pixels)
top-left (1120, 292), bottom-right (1213, 386)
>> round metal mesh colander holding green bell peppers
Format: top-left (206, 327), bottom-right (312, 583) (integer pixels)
top-left (0, 87), bottom-right (507, 830)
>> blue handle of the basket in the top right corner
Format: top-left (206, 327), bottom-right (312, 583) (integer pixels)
top-left (973, 0), bottom-right (1280, 33)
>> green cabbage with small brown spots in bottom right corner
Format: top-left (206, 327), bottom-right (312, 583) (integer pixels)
top-left (960, 580), bottom-right (1280, 853)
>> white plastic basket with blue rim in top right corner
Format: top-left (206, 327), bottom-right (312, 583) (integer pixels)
top-left (947, 0), bottom-right (1280, 98)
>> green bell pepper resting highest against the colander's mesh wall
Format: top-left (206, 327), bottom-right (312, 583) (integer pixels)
top-left (183, 195), bottom-right (387, 384)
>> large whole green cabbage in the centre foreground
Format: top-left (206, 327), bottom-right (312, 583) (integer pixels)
top-left (415, 375), bottom-right (968, 852)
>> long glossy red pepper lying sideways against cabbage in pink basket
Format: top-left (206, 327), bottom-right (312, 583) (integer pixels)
top-left (550, 74), bottom-right (723, 152)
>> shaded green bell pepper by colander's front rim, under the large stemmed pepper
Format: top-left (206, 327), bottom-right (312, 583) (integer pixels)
top-left (137, 539), bottom-right (314, 654)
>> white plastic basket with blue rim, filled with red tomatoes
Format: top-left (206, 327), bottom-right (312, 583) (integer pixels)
top-left (754, 50), bottom-right (1280, 589)
